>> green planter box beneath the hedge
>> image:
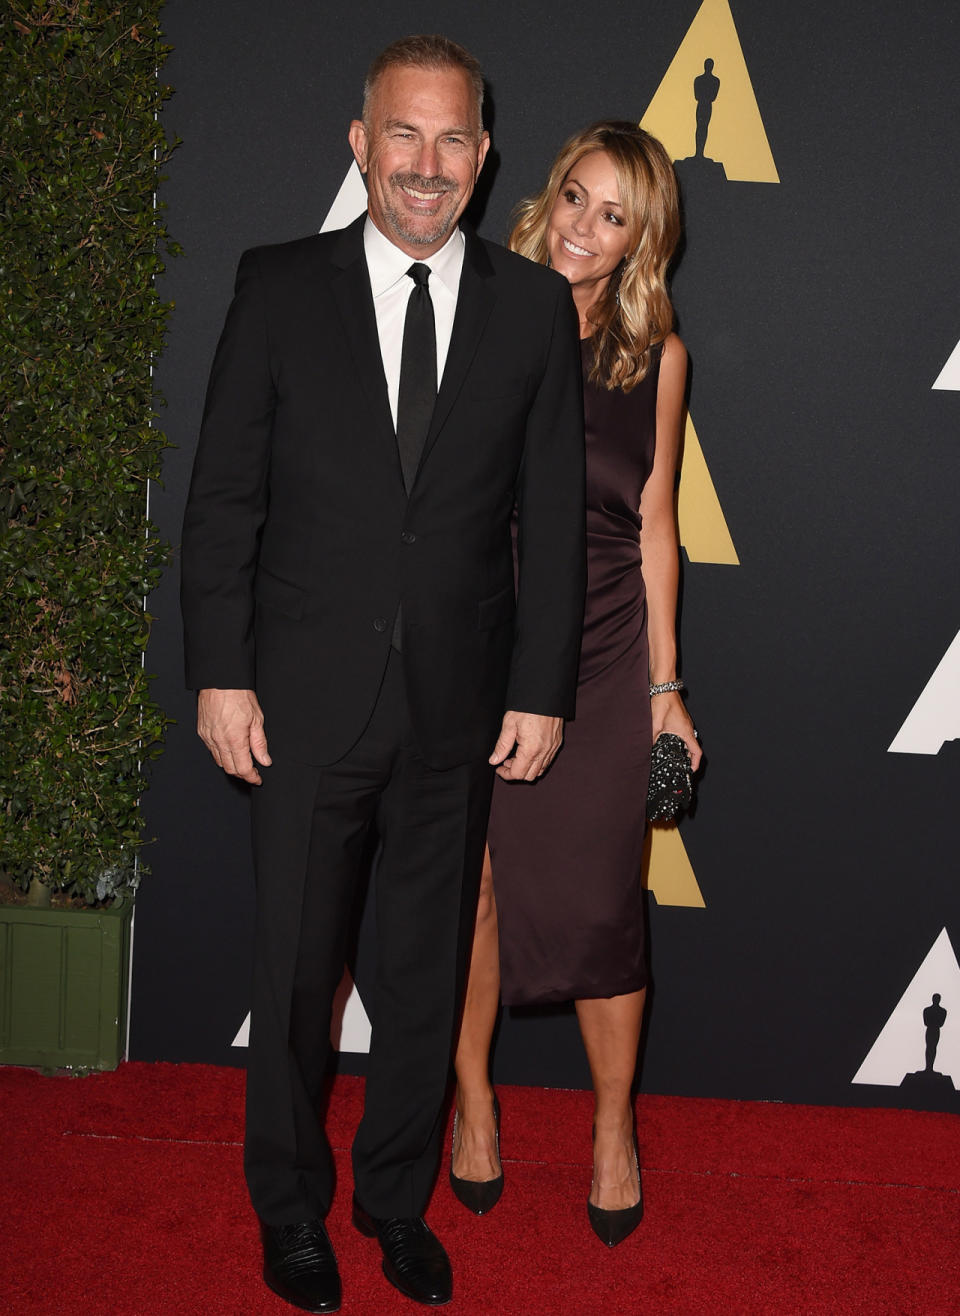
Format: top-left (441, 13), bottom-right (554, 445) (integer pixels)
top-left (0, 901), bottom-right (133, 1070)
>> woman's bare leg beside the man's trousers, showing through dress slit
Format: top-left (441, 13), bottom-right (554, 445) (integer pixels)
top-left (452, 850), bottom-right (500, 1182)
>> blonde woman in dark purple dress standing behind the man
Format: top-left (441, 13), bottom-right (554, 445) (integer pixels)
top-left (450, 121), bottom-right (701, 1246)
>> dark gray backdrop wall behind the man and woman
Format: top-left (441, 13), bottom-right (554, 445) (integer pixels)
top-left (132, 0), bottom-right (960, 1105)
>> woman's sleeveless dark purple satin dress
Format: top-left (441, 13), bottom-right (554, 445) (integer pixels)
top-left (487, 342), bottom-right (660, 1005)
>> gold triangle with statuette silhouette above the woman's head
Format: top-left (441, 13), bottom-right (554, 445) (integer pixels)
top-left (640, 0), bottom-right (780, 183)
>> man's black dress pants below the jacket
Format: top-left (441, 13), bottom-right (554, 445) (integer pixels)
top-left (244, 650), bottom-right (493, 1225)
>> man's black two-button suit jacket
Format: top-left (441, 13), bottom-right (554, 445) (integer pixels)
top-left (182, 217), bottom-right (585, 767)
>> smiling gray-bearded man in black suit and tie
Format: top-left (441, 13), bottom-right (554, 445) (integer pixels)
top-left (183, 37), bottom-right (585, 1312)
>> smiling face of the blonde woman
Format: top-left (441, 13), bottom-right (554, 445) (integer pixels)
top-left (547, 151), bottom-right (631, 296)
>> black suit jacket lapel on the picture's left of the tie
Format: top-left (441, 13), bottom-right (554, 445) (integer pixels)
top-left (332, 212), bottom-right (403, 457)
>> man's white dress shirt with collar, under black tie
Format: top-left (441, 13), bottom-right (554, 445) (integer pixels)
top-left (363, 215), bottom-right (464, 429)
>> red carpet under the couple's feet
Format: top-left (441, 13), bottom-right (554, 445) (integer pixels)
top-left (0, 1065), bottom-right (960, 1316)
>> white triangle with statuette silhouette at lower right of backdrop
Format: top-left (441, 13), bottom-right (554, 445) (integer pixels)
top-left (853, 928), bottom-right (960, 1088)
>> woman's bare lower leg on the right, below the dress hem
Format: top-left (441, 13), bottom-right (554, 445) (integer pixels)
top-left (577, 991), bottom-right (647, 1211)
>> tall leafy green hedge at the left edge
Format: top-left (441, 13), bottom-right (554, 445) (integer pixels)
top-left (0, 0), bottom-right (174, 903)
